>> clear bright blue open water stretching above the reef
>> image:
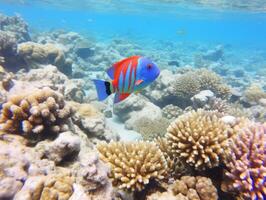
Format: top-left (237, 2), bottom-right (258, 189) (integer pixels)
top-left (0, 0), bottom-right (266, 49)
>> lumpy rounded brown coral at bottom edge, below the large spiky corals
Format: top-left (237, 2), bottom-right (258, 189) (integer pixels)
top-left (147, 176), bottom-right (218, 200)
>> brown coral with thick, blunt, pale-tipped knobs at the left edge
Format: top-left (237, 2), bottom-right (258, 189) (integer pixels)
top-left (0, 88), bottom-right (72, 139)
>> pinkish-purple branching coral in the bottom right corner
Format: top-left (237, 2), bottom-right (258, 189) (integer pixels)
top-left (222, 124), bottom-right (266, 200)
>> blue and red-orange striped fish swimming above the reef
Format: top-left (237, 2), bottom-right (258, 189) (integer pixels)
top-left (93, 56), bottom-right (160, 103)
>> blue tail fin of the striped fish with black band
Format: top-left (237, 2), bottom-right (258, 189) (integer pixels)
top-left (93, 79), bottom-right (113, 101)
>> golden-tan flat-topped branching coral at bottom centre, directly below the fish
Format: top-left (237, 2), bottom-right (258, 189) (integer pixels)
top-left (97, 142), bottom-right (167, 191)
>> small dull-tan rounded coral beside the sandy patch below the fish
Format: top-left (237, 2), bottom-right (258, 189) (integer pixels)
top-left (134, 117), bottom-right (170, 140)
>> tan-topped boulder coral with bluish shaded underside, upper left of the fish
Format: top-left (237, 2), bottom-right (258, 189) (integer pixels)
top-left (18, 42), bottom-right (72, 75)
